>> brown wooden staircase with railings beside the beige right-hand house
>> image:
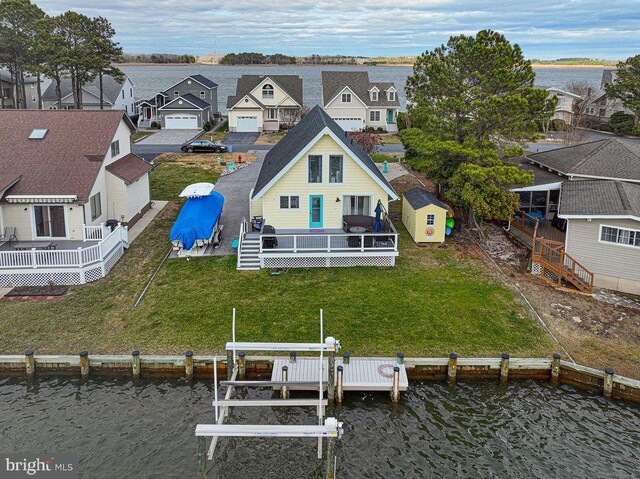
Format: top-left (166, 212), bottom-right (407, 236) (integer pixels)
top-left (531, 237), bottom-right (593, 294)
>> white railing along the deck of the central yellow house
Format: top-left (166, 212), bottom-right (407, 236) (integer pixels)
top-left (260, 232), bottom-right (398, 255)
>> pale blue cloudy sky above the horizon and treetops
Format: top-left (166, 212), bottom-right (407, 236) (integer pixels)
top-left (37, 0), bottom-right (640, 59)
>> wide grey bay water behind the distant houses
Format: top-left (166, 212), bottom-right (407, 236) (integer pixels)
top-left (120, 65), bottom-right (602, 112)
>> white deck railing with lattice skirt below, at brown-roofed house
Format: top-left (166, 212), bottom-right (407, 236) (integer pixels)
top-left (0, 225), bottom-right (129, 287)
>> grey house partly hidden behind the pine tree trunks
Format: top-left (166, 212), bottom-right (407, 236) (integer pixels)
top-left (42, 75), bottom-right (136, 116)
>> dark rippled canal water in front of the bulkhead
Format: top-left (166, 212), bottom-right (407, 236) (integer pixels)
top-left (0, 377), bottom-right (640, 479)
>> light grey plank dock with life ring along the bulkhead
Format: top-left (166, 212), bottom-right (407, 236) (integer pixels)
top-left (271, 357), bottom-right (409, 391)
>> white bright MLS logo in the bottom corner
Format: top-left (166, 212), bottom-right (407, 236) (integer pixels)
top-left (0, 454), bottom-right (78, 479)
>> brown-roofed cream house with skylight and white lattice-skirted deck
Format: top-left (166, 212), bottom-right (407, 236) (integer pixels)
top-left (0, 110), bottom-right (151, 287)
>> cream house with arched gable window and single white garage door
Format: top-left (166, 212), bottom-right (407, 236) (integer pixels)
top-left (227, 75), bottom-right (302, 132)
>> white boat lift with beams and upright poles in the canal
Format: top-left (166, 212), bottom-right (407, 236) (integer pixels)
top-left (195, 308), bottom-right (343, 479)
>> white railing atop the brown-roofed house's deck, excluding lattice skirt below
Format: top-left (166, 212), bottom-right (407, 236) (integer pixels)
top-left (0, 225), bottom-right (129, 269)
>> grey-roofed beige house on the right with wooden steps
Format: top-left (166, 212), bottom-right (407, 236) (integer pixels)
top-left (510, 139), bottom-right (640, 294)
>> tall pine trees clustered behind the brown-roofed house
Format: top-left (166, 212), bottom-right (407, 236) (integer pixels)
top-left (0, 0), bottom-right (124, 109)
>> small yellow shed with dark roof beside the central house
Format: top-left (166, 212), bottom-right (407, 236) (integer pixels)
top-left (402, 188), bottom-right (448, 243)
